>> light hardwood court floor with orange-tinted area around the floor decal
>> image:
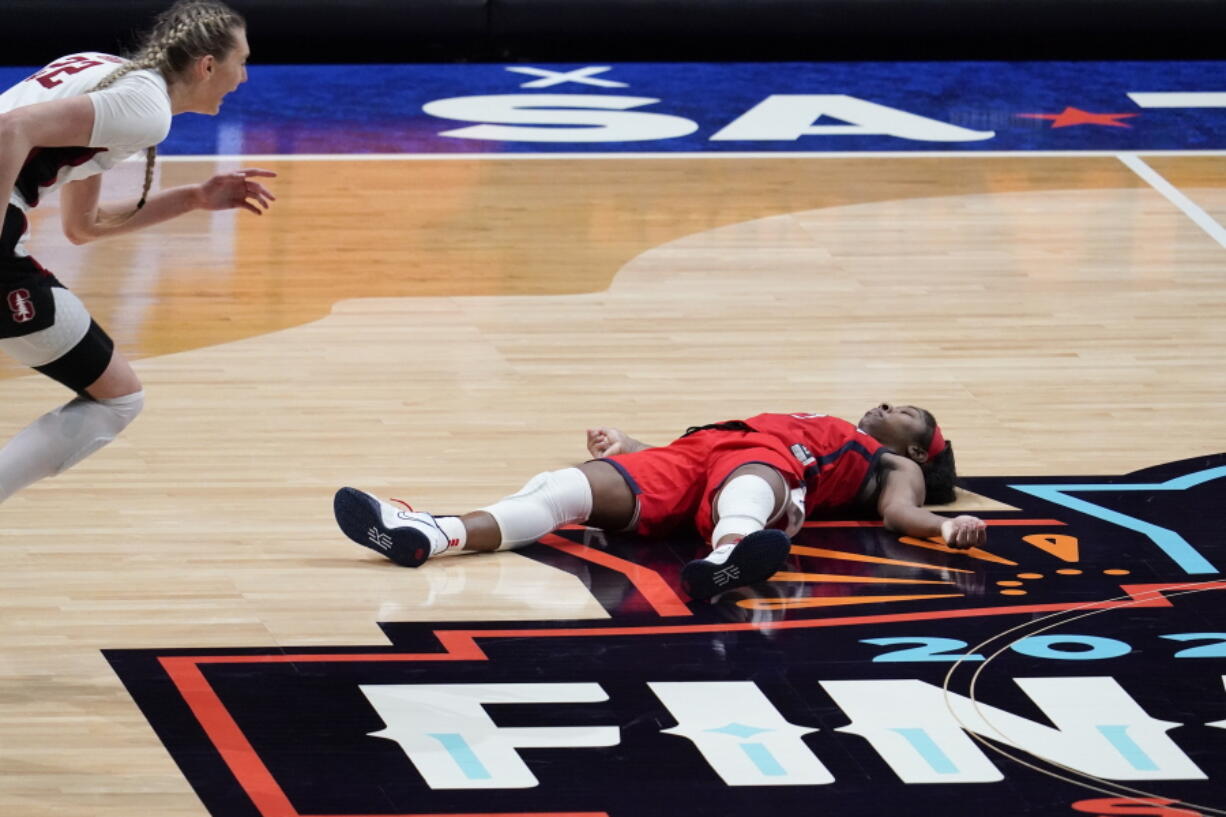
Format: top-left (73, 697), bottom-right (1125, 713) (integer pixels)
top-left (0, 58), bottom-right (1226, 817)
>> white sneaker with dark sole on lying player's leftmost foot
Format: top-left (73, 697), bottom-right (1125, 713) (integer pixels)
top-left (332, 488), bottom-right (449, 567)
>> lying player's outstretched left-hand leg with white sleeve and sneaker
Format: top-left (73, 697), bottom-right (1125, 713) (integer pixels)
top-left (332, 460), bottom-right (635, 567)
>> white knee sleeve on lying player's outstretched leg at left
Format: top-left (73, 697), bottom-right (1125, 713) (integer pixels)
top-left (479, 469), bottom-right (592, 550)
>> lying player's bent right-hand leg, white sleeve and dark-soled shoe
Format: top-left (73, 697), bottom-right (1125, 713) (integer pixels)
top-left (682, 462), bottom-right (791, 599)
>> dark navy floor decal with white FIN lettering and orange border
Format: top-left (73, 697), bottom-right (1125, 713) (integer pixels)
top-left (107, 454), bottom-right (1226, 817)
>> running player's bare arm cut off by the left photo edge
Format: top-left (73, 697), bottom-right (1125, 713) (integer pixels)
top-left (0, 97), bottom-right (93, 206)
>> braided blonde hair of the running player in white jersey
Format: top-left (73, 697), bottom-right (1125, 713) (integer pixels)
top-left (93, 0), bottom-right (246, 209)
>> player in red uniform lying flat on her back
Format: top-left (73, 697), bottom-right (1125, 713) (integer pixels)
top-left (333, 404), bottom-right (987, 599)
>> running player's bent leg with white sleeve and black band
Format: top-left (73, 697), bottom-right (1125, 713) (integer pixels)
top-left (0, 287), bottom-right (143, 502)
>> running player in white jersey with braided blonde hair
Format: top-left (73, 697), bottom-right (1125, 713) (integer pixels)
top-left (0, 0), bottom-right (275, 502)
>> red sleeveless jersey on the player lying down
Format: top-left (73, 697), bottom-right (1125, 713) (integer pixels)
top-left (730, 413), bottom-right (889, 515)
